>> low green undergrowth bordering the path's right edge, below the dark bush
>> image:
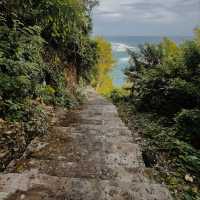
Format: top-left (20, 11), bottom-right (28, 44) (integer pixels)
top-left (116, 97), bottom-right (200, 200)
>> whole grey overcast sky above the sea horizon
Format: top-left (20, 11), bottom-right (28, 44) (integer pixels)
top-left (93, 0), bottom-right (200, 36)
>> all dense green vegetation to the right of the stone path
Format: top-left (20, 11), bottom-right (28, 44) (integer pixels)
top-left (111, 29), bottom-right (200, 200)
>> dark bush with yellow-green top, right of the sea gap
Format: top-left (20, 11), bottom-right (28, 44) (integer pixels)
top-left (126, 31), bottom-right (200, 119)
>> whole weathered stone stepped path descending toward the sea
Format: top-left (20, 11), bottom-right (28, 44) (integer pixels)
top-left (0, 89), bottom-right (171, 200)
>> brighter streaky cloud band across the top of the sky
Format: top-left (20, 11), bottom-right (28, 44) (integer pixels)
top-left (96, 0), bottom-right (200, 23)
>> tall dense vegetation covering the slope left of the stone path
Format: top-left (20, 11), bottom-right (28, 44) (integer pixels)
top-left (0, 0), bottom-right (99, 170)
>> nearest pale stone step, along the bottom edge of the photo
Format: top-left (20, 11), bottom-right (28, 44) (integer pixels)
top-left (0, 170), bottom-right (171, 200)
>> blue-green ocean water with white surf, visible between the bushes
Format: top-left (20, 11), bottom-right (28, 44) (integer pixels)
top-left (105, 36), bottom-right (191, 86)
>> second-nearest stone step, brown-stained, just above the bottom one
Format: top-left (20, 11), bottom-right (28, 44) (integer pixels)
top-left (4, 160), bottom-right (145, 183)
